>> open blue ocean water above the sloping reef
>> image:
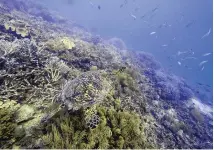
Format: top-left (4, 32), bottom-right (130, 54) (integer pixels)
top-left (39, 0), bottom-right (213, 101)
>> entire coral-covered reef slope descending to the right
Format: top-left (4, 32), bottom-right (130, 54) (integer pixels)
top-left (0, 0), bottom-right (213, 149)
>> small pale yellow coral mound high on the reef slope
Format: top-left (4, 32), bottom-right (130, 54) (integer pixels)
top-left (46, 37), bottom-right (75, 51)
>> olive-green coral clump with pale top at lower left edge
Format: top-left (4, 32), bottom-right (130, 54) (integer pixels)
top-left (0, 100), bottom-right (20, 148)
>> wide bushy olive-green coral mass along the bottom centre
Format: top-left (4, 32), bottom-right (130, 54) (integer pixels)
top-left (43, 106), bottom-right (146, 149)
